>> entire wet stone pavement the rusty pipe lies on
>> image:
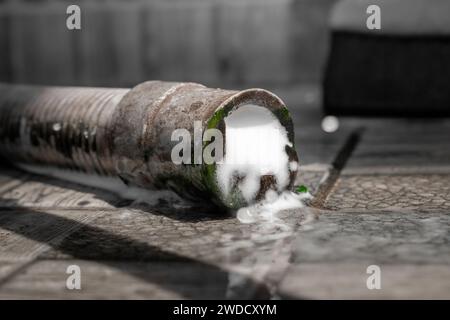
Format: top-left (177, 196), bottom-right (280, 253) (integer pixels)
top-left (0, 86), bottom-right (450, 299)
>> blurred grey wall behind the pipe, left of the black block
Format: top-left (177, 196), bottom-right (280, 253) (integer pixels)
top-left (0, 0), bottom-right (336, 87)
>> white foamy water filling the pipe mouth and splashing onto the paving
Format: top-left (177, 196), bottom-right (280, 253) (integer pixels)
top-left (217, 105), bottom-right (310, 223)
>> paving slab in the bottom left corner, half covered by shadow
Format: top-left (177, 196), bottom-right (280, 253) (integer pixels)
top-left (0, 260), bottom-right (229, 299)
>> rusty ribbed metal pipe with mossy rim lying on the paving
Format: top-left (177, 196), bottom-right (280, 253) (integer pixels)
top-left (0, 81), bottom-right (298, 208)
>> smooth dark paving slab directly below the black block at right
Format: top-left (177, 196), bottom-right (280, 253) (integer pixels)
top-left (342, 119), bottom-right (450, 175)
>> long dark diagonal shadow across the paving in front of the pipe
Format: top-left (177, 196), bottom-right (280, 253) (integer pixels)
top-left (0, 207), bottom-right (278, 299)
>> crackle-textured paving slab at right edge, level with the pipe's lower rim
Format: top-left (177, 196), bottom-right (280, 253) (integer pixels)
top-left (324, 174), bottom-right (450, 213)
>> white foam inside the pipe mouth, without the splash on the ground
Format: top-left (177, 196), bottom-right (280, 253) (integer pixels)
top-left (217, 105), bottom-right (295, 203)
